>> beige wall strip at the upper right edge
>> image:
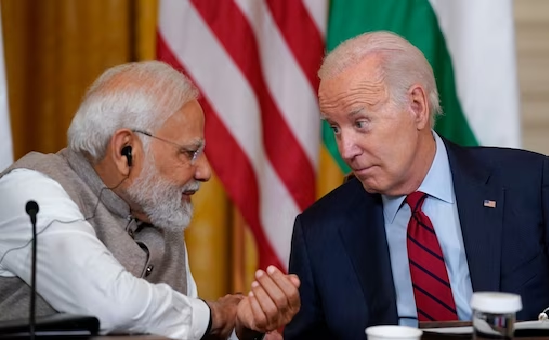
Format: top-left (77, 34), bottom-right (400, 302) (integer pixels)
top-left (515, 0), bottom-right (549, 154)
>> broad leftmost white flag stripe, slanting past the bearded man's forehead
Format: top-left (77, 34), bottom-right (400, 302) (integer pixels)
top-left (159, 0), bottom-right (264, 173)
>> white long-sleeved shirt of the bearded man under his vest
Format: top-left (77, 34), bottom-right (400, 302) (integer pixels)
top-left (0, 169), bottom-right (210, 339)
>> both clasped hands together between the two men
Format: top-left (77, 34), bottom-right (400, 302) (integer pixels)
top-left (205, 266), bottom-right (301, 340)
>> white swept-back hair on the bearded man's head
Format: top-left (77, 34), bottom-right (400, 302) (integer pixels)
top-left (67, 61), bottom-right (198, 162)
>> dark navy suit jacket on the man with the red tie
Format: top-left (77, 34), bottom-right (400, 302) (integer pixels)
top-left (285, 141), bottom-right (549, 340)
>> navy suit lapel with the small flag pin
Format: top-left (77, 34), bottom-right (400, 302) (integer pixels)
top-left (445, 140), bottom-right (504, 291)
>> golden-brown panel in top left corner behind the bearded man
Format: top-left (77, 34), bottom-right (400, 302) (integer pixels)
top-left (0, 0), bottom-right (131, 158)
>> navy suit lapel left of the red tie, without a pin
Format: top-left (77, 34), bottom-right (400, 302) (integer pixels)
top-left (339, 179), bottom-right (398, 325)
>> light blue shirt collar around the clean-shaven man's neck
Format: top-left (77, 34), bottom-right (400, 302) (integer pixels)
top-left (381, 131), bottom-right (455, 223)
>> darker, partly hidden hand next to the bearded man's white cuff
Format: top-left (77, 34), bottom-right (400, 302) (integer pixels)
top-left (206, 294), bottom-right (244, 339)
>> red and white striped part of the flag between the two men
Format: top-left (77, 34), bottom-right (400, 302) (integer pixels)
top-left (158, 0), bottom-right (328, 269)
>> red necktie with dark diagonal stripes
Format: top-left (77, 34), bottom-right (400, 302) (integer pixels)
top-left (406, 191), bottom-right (458, 321)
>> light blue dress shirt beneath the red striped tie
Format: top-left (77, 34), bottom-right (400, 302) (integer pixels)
top-left (382, 132), bottom-right (473, 327)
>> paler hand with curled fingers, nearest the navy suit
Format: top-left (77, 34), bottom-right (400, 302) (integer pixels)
top-left (236, 266), bottom-right (301, 339)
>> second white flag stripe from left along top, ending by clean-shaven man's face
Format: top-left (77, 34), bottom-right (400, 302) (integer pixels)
top-left (236, 0), bottom-right (320, 169)
